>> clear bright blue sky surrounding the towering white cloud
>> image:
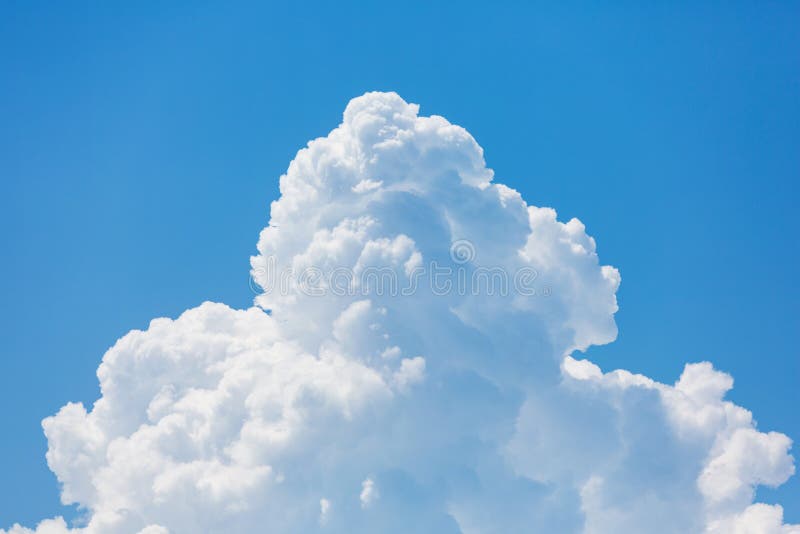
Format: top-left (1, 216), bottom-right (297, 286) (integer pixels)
top-left (0, 1), bottom-right (800, 525)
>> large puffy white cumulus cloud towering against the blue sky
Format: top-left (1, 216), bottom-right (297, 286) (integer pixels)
top-left (0, 93), bottom-right (800, 534)
